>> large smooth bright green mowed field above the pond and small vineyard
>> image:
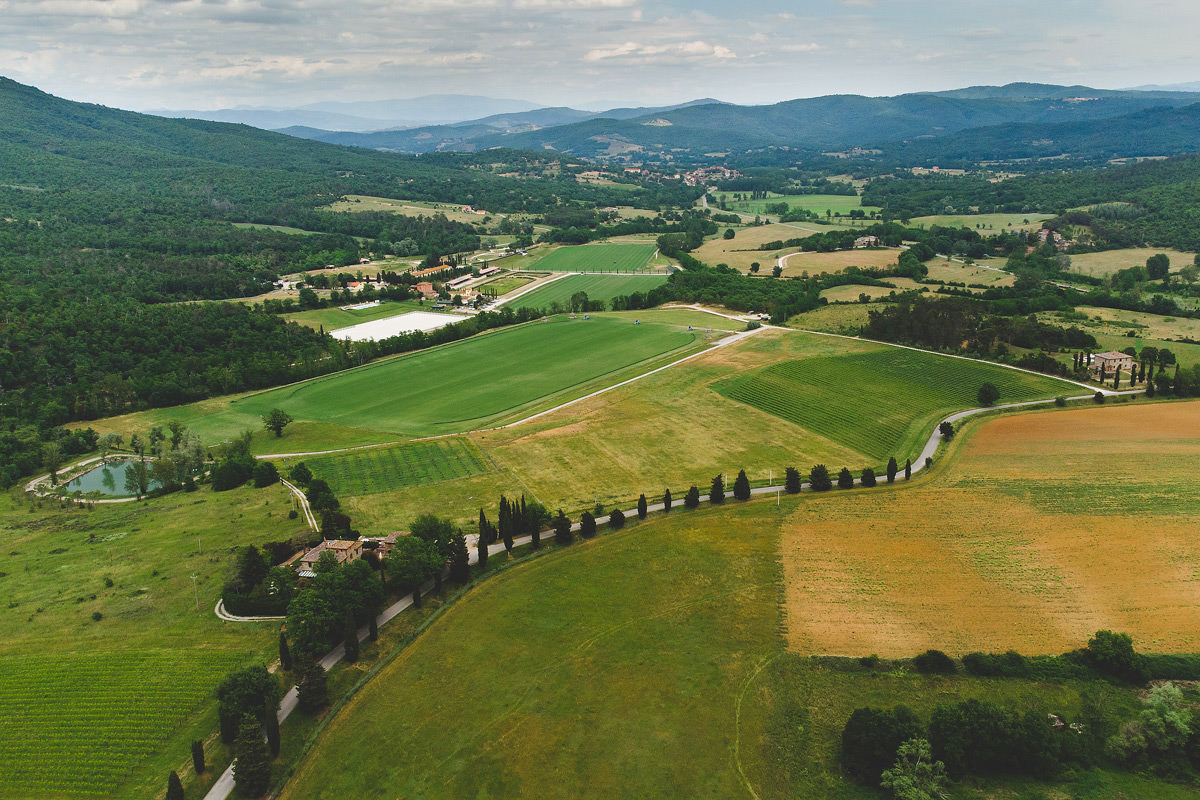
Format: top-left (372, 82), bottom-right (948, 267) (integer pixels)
top-left (95, 314), bottom-right (706, 452)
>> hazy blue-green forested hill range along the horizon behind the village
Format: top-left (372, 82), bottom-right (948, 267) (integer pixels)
top-left (267, 83), bottom-right (1198, 163)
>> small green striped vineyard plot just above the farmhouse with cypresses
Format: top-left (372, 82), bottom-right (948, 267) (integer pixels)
top-left (305, 438), bottom-right (490, 495)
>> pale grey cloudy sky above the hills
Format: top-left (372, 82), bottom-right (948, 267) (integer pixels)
top-left (0, 0), bottom-right (1200, 110)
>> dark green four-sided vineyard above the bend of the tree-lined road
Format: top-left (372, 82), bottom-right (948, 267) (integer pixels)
top-left (714, 348), bottom-right (1078, 467)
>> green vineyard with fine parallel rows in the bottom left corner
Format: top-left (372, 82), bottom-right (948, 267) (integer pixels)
top-left (0, 650), bottom-right (241, 796)
